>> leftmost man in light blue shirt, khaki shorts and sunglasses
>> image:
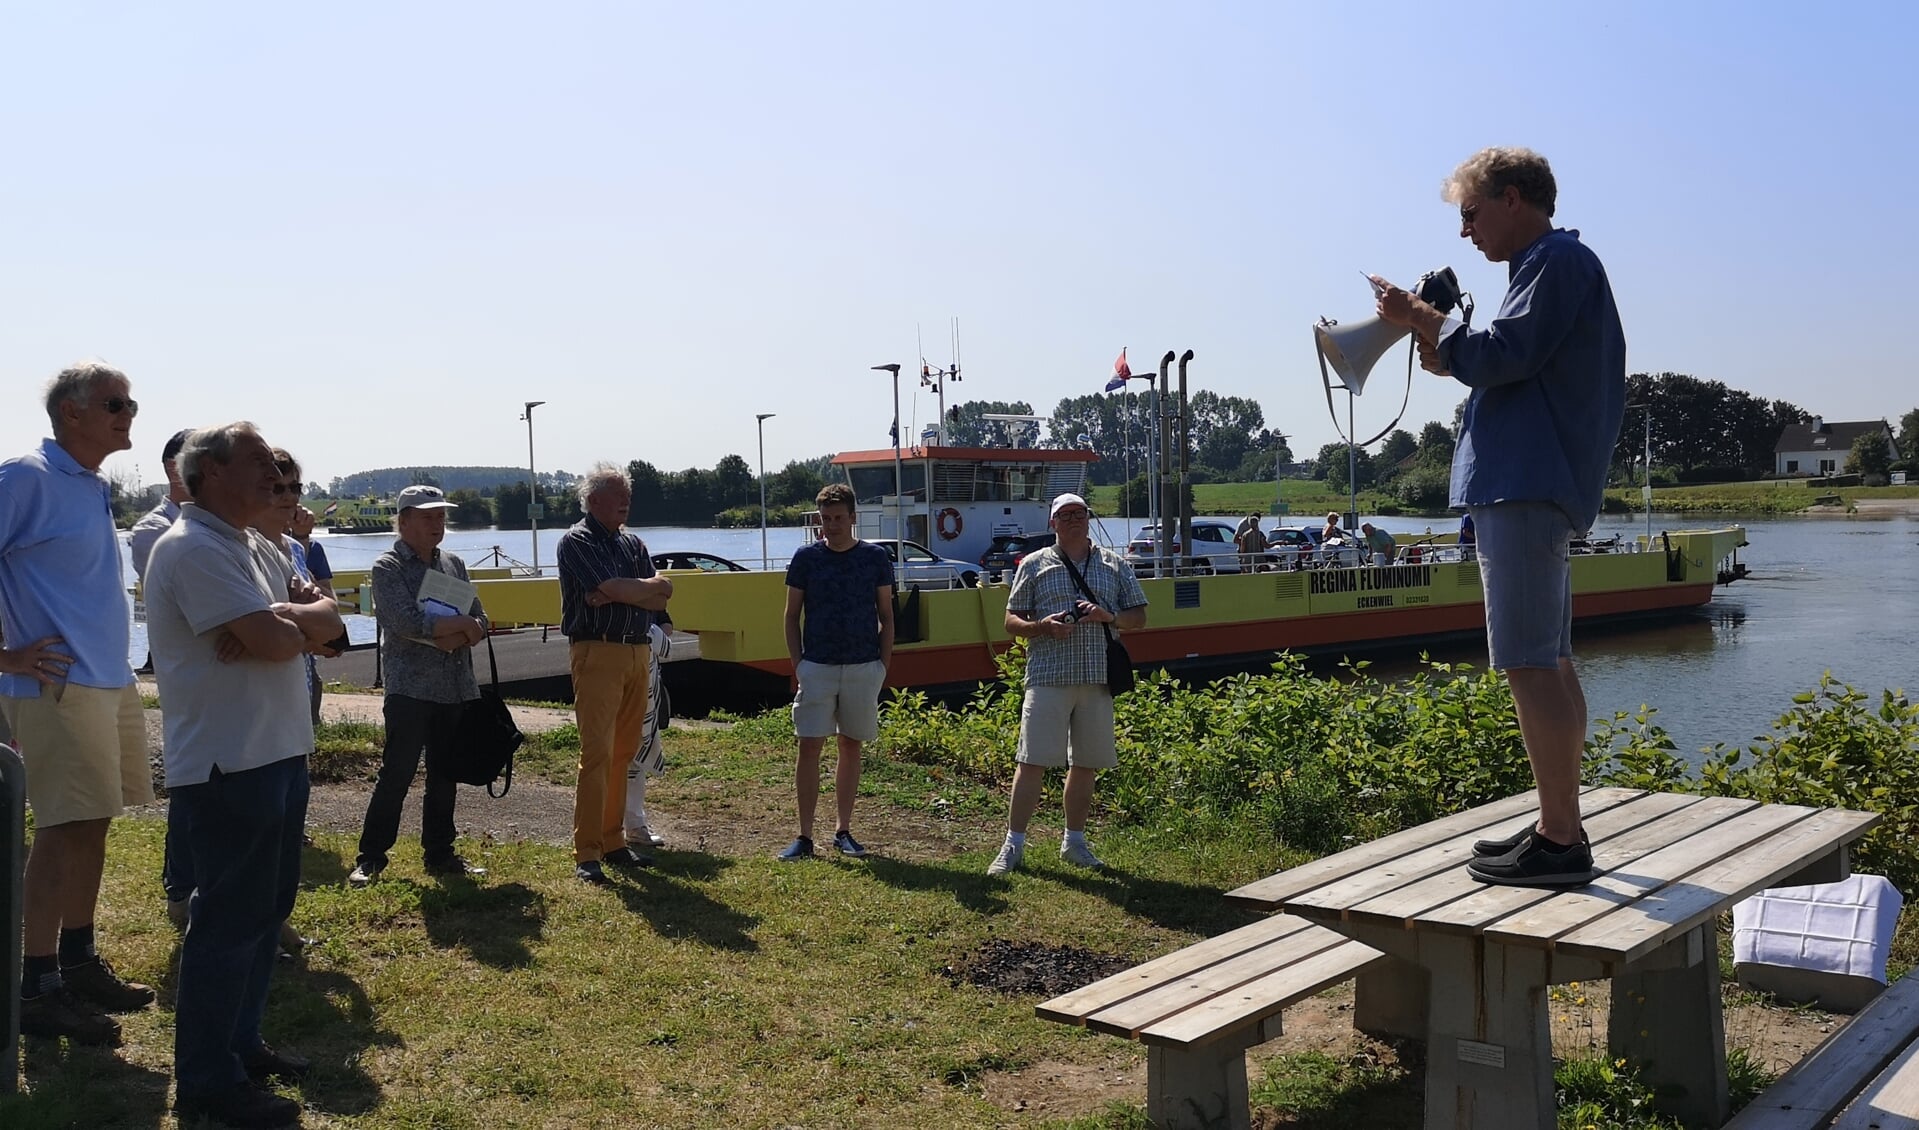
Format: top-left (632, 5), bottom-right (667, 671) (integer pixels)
top-left (0, 363), bottom-right (154, 1044)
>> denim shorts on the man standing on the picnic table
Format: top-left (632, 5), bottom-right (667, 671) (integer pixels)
top-left (1470, 503), bottom-right (1572, 671)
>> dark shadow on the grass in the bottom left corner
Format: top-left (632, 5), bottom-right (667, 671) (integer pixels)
top-left (0, 1036), bottom-right (173, 1128)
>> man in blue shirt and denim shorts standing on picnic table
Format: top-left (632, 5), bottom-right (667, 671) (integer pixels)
top-left (1374, 148), bottom-right (1625, 886)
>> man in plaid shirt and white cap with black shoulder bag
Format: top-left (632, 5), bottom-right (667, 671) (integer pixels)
top-left (986, 495), bottom-right (1146, 875)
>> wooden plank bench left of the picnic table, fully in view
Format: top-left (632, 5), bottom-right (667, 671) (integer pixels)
top-left (1034, 915), bottom-right (1397, 1128)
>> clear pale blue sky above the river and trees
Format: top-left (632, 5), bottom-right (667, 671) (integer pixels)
top-left (0, 2), bottom-right (1919, 482)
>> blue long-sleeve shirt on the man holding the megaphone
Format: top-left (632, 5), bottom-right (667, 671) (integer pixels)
top-left (1439, 228), bottom-right (1625, 531)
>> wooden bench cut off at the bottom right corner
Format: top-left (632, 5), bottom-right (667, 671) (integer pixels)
top-left (1725, 977), bottom-right (1919, 1130)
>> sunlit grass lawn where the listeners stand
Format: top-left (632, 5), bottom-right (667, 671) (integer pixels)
top-left (0, 731), bottom-right (1278, 1130)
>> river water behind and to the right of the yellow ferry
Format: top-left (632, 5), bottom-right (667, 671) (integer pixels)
top-left (127, 514), bottom-right (1919, 760)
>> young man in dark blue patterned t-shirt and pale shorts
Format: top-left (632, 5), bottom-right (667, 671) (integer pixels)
top-left (779, 483), bottom-right (892, 863)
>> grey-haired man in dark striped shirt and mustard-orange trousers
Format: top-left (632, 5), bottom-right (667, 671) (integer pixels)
top-left (558, 462), bottom-right (674, 884)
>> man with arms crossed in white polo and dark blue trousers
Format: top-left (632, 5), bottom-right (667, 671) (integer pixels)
top-left (148, 422), bottom-right (345, 1126)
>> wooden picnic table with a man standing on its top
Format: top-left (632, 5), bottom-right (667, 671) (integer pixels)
top-left (1226, 789), bottom-right (1879, 1130)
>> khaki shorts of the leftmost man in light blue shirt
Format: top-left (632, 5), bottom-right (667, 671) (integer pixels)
top-left (0, 683), bottom-right (154, 829)
